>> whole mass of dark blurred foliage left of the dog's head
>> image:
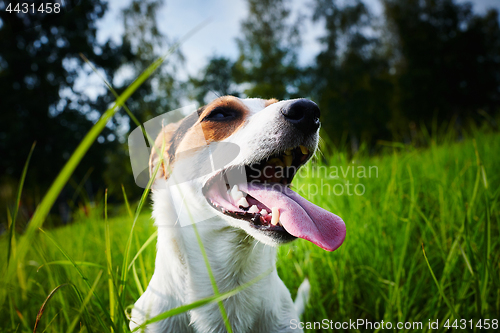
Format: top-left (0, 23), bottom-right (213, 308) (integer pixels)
top-left (0, 0), bottom-right (187, 220)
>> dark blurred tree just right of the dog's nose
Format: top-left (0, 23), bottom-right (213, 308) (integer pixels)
top-left (309, 0), bottom-right (392, 149)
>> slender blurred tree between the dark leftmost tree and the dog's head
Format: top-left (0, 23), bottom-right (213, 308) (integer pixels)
top-left (100, 0), bottom-right (184, 198)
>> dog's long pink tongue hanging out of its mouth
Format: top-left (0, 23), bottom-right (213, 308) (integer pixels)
top-left (240, 184), bottom-right (346, 251)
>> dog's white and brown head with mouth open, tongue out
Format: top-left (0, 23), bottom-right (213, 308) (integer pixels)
top-left (150, 96), bottom-right (345, 251)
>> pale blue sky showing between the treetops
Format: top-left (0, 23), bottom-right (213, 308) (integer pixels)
top-left (97, 0), bottom-right (500, 77)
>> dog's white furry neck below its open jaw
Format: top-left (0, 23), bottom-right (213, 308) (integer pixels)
top-left (155, 220), bottom-right (276, 294)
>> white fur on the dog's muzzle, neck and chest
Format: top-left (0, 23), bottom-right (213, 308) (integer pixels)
top-left (130, 99), bottom-right (317, 333)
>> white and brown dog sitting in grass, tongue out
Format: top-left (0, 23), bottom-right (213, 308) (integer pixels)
top-left (130, 96), bottom-right (346, 333)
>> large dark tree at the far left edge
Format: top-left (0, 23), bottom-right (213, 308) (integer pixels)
top-left (0, 0), bottom-right (127, 220)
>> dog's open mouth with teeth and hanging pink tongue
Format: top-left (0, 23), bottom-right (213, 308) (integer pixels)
top-left (203, 146), bottom-right (345, 251)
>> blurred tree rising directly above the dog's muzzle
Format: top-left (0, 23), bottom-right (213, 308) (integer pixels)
top-left (234, 0), bottom-right (300, 99)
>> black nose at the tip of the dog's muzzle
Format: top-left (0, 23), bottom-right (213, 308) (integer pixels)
top-left (280, 99), bottom-right (320, 134)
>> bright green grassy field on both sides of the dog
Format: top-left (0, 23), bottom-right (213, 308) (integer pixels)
top-left (0, 125), bottom-right (500, 332)
